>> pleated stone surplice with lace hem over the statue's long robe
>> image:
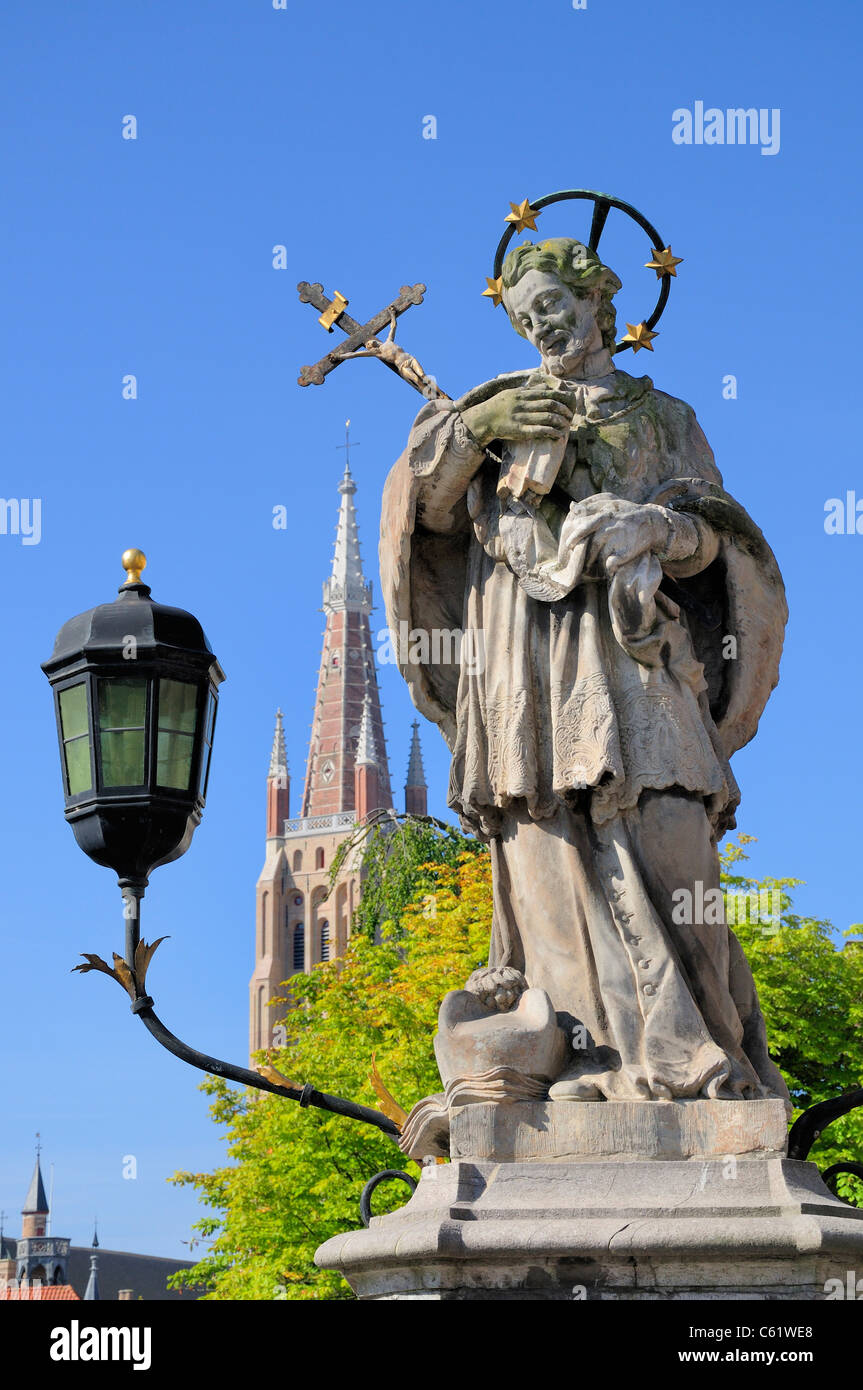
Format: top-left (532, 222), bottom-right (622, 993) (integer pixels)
top-left (450, 467), bottom-right (737, 834)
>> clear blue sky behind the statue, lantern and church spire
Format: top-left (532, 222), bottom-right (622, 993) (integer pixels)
top-left (0, 0), bottom-right (863, 1255)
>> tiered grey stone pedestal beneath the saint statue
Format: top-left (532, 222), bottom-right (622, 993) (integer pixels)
top-left (315, 1101), bottom-right (863, 1300)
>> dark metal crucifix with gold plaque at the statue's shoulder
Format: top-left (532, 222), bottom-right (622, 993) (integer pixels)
top-left (297, 279), bottom-right (450, 400)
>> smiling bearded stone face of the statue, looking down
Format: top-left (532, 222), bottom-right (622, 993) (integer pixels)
top-left (506, 270), bottom-right (602, 377)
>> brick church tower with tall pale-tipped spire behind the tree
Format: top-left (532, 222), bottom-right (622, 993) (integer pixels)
top-left (249, 455), bottom-right (427, 1052)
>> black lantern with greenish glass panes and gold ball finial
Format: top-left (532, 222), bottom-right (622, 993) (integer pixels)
top-left (42, 550), bottom-right (225, 894)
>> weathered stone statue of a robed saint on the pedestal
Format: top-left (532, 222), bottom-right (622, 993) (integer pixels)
top-left (381, 238), bottom-right (788, 1102)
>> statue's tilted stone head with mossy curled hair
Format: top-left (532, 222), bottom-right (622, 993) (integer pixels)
top-left (502, 236), bottom-right (620, 377)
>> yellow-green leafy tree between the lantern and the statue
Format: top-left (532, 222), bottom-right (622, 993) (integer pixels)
top-left (172, 820), bottom-right (491, 1300)
